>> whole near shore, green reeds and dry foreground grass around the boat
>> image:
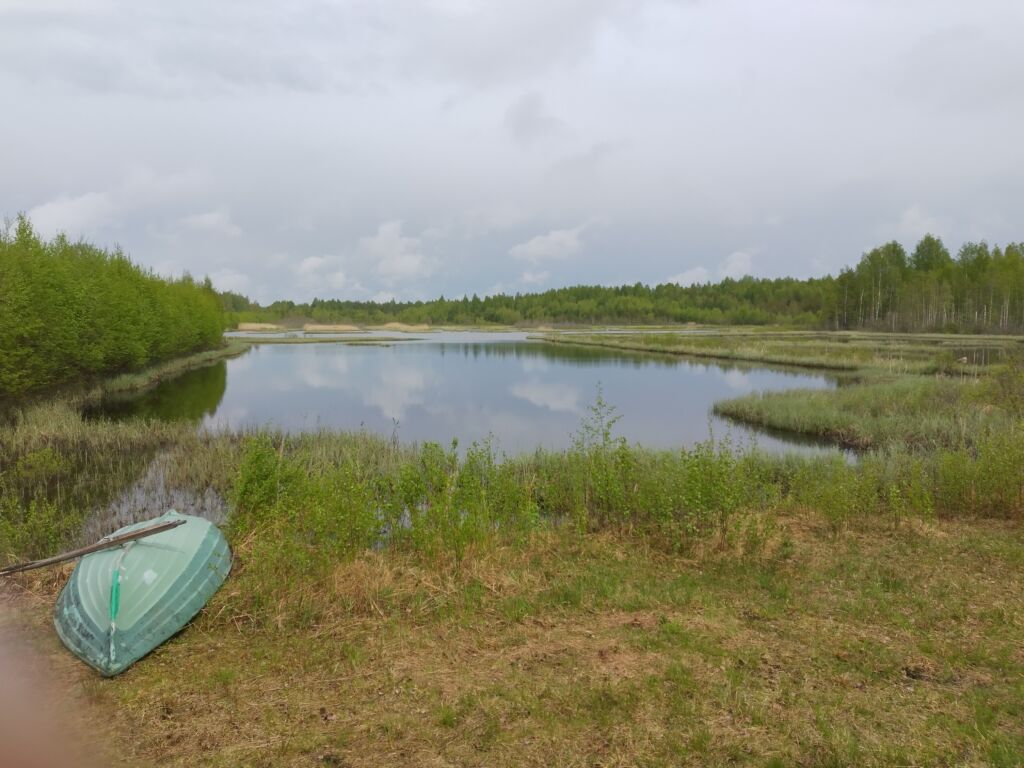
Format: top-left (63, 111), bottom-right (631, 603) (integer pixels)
top-left (0, 333), bottom-right (1024, 767)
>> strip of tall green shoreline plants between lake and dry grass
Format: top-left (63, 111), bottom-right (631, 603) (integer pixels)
top-left (0, 385), bottom-right (1024, 573)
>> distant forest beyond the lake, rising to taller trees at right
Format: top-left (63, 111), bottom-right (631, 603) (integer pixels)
top-left (221, 234), bottom-right (1024, 333)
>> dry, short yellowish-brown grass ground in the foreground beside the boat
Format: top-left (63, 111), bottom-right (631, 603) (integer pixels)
top-left (4, 512), bottom-right (1024, 766)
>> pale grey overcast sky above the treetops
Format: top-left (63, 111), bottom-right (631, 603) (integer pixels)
top-left (0, 0), bottom-right (1024, 301)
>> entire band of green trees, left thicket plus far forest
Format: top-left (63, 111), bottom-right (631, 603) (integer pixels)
top-left (0, 216), bottom-right (1024, 396)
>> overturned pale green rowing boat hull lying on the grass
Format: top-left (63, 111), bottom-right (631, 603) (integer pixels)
top-left (53, 510), bottom-right (231, 677)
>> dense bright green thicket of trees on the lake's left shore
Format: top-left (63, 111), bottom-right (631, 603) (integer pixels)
top-left (0, 216), bottom-right (223, 395)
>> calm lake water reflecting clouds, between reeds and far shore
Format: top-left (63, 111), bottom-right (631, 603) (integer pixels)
top-left (94, 333), bottom-right (847, 454)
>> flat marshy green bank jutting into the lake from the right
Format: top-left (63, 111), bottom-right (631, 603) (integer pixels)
top-left (544, 331), bottom-right (1024, 452)
